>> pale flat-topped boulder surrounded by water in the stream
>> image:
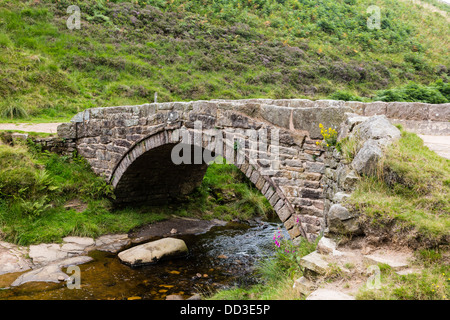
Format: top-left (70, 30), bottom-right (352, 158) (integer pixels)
top-left (118, 238), bottom-right (188, 267)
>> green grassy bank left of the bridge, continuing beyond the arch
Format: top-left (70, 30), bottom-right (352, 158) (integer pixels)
top-left (0, 139), bottom-right (272, 245)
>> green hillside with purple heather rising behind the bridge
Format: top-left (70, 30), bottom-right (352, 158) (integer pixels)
top-left (0, 0), bottom-right (450, 121)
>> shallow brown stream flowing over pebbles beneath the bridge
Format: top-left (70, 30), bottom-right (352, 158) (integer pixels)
top-left (0, 222), bottom-right (286, 300)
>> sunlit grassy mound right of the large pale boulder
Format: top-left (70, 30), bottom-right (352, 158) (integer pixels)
top-left (349, 131), bottom-right (450, 246)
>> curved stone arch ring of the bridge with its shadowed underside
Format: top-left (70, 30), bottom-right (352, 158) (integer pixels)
top-left (110, 128), bottom-right (308, 238)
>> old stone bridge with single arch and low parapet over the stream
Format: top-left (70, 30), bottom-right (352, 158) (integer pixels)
top-left (58, 99), bottom-right (449, 240)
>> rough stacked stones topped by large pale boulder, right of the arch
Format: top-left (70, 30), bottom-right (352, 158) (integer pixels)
top-left (322, 114), bottom-right (400, 235)
